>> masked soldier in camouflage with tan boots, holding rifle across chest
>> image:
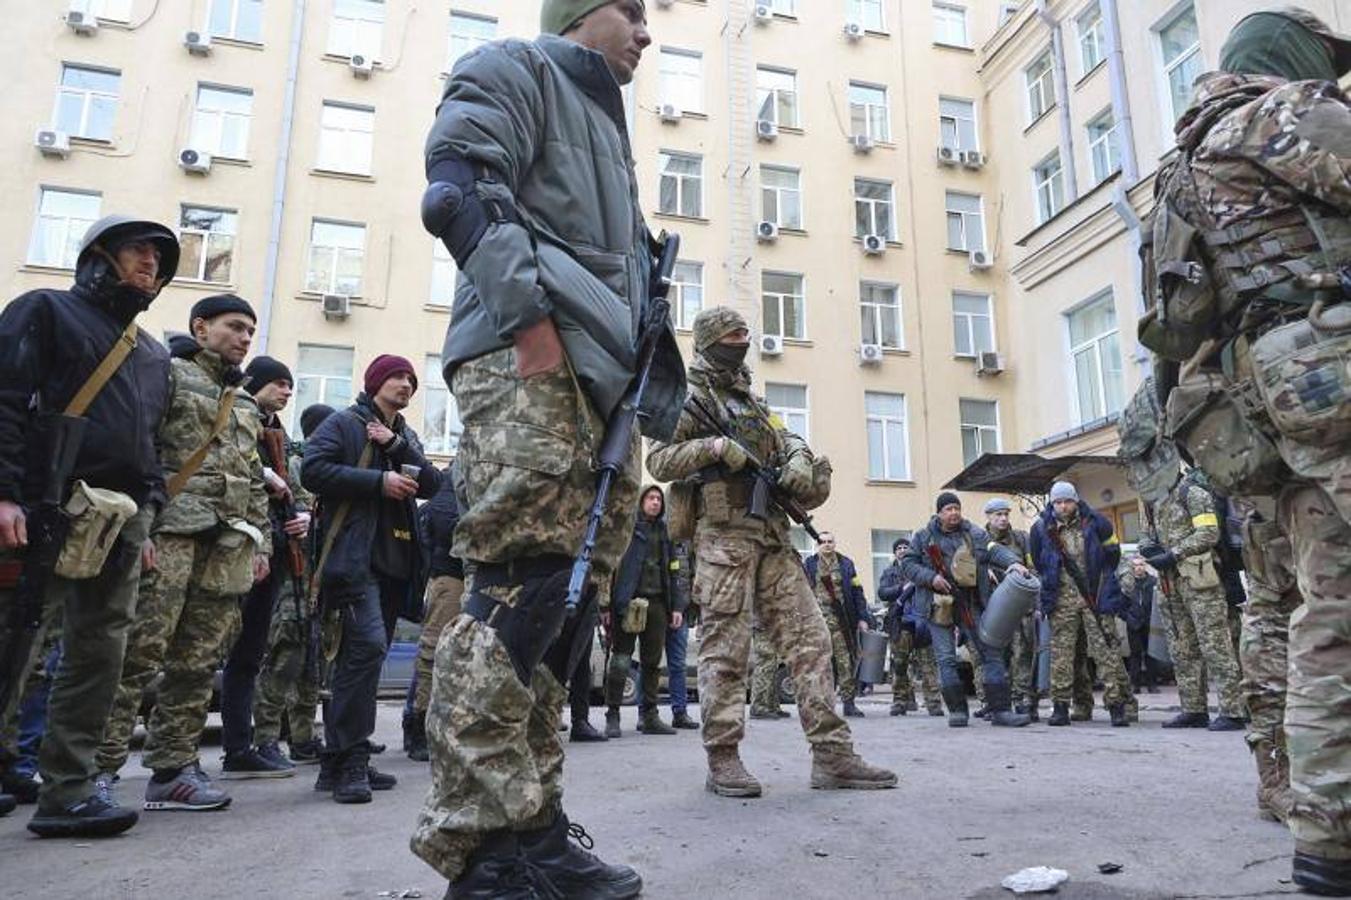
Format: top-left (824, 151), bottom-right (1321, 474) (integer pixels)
top-left (647, 307), bottom-right (896, 797)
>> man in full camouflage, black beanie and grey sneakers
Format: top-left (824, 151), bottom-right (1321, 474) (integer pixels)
top-left (95, 295), bottom-right (272, 811)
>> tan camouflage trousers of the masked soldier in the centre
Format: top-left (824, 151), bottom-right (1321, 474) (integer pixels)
top-left (693, 530), bottom-right (851, 749)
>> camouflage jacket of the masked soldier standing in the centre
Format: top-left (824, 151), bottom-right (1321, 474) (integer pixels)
top-left (647, 357), bottom-right (811, 546)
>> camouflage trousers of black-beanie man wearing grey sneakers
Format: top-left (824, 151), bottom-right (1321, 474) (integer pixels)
top-left (95, 532), bottom-right (240, 772)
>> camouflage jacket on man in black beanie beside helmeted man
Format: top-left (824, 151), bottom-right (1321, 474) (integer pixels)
top-left (154, 347), bottom-right (272, 553)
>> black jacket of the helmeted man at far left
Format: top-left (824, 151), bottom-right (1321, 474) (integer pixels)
top-left (0, 285), bottom-right (169, 505)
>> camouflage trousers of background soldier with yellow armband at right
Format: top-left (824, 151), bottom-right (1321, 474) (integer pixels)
top-left (1163, 573), bottom-right (1244, 719)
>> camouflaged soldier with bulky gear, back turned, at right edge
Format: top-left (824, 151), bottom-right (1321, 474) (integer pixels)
top-left (1142, 8), bottom-right (1351, 881)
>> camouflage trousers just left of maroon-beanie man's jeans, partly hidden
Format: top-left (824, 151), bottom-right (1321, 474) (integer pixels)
top-left (253, 591), bottom-right (324, 745)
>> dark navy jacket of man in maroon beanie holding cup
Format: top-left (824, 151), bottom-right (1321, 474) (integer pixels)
top-left (300, 395), bottom-right (440, 603)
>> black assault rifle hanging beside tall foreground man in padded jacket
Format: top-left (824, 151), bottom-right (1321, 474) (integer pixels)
top-left (566, 231), bottom-right (680, 616)
